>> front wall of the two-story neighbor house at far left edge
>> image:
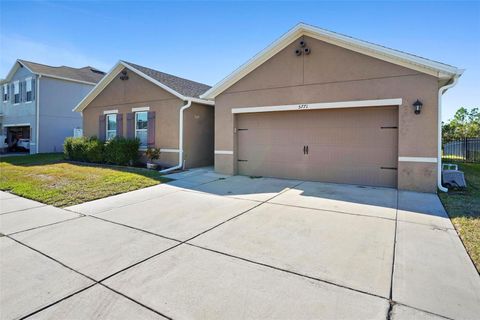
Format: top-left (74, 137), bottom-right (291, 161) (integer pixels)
top-left (0, 67), bottom-right (37, 153)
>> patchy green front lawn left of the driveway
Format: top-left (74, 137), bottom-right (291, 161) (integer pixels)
top-left (0, 153), bottom-right (169, 207)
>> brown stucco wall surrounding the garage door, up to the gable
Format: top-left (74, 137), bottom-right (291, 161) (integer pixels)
top-left (215, 37), bottom-right (438, 192)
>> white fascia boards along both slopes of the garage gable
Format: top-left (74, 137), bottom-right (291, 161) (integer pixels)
top-left (200, 23), bottom-right (463, 99)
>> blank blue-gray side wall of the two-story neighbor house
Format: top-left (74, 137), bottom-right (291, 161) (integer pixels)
top-left (39, 77), bottom-right (93, 153)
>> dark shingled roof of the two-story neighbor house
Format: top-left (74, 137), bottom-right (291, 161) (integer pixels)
top-left (18, 60), bottom-right (105, 83)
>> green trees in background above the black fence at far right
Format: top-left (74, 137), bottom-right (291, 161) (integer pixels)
top-left (442, 107), bottom-right (480, 143)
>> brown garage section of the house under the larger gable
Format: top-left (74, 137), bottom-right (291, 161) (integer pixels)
top-left (200, 24), bottom-right (463, 192)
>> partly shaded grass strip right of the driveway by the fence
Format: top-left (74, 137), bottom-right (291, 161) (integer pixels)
top-left (440, 161), bottom-right (480, 272)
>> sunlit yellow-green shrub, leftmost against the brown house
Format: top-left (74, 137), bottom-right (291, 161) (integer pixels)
top-left (63, 137), bottom-right (104, 162)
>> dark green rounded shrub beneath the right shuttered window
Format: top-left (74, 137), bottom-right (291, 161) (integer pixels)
top-left (104, 137), bottom-right (140, 165)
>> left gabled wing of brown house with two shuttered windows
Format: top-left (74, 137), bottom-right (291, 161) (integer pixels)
top-left (74, 61), bottom-right (214, 169)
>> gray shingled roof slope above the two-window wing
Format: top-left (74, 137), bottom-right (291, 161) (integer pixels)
top-left (123, 61), bottom-right (211, 98)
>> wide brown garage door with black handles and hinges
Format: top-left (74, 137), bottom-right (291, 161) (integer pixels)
top-left (237, 107), bottom-right (398, 187)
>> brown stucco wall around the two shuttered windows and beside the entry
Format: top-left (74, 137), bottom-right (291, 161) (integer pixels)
top-left (83, 71), bottom-right (213, 167)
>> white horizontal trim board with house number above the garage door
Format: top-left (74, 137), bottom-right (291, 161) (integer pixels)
top-left (232, 98), bottom-right (403, 114)
